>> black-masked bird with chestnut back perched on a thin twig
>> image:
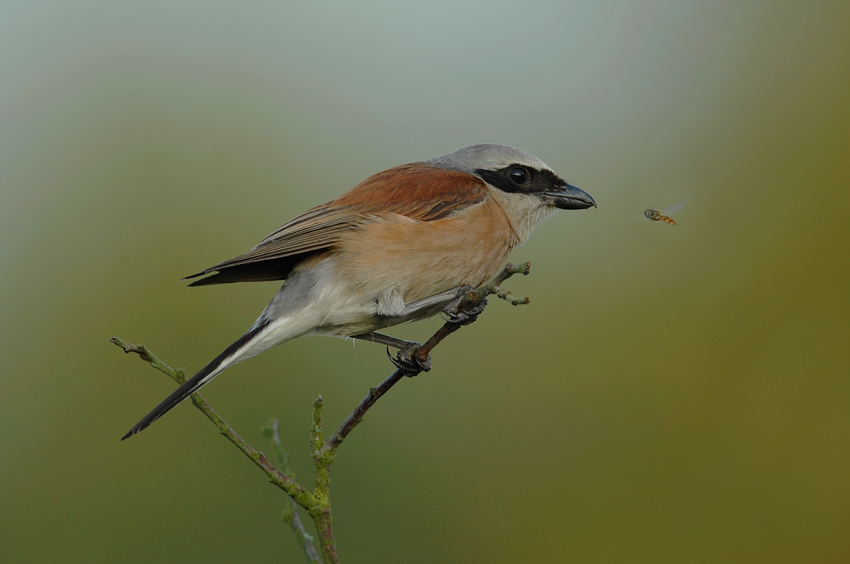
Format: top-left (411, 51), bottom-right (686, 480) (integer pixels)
top-left (121, 144), bottom-right (596, 440)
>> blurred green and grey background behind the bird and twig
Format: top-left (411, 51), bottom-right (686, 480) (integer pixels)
top-left (0, 0), bottom-right (850, 563)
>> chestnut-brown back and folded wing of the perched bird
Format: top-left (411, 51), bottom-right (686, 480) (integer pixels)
top-left (184, 163), bottom-right (487, 286)
